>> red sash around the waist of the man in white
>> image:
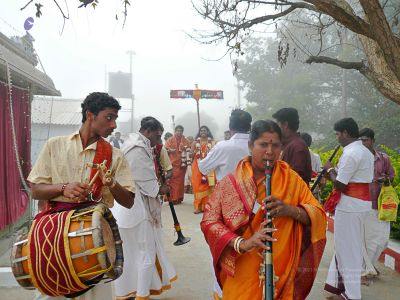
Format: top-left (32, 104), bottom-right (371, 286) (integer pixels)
top-left (324, 182), bottom-right (370, 214)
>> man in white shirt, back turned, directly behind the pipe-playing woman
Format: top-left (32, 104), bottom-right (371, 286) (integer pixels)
top-left (199, 109), bottom-right (252, 299)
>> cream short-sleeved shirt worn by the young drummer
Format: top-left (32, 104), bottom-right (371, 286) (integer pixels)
top-left (28, 131), bottom-right (135, 207)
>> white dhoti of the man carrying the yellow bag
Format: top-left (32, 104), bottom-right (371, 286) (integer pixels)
top-left (363, 210), bottom-right (390, 275)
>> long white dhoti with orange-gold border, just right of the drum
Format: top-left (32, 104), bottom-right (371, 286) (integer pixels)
top-left (115, 220), bottom-right (176, 299)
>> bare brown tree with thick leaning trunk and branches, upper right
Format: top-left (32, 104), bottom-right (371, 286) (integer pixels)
top-left (193, 0), bottom-right (400, 104)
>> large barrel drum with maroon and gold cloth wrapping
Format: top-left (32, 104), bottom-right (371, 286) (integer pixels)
top-left (11, 204), bottom-right (124, 296)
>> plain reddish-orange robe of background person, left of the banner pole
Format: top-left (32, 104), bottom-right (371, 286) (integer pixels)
top-left (165, 135), bottom-right (190, 203)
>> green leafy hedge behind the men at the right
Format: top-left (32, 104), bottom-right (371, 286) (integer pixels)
top-left (313, 145), bottom-right (400, 240)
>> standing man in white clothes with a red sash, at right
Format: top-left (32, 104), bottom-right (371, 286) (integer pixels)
top-left (324, 118), bottom-right (374, 299)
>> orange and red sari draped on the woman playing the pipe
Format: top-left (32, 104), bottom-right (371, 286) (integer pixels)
top-left (201, 157), bottom-right (326, 300)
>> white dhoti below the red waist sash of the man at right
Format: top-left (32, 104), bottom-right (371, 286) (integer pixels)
top-left (325, 210), bottom-right (369, 299)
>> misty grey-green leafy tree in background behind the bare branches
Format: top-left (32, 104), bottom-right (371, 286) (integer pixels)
top-left (237, 38), bottom-right (400, 148)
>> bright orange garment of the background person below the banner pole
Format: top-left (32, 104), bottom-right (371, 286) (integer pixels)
top-left (192, 143), bottom-right (215, 211)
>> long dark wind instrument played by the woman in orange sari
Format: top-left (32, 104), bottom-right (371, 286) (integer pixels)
top-left (264, 161), bottom-right (274, 300)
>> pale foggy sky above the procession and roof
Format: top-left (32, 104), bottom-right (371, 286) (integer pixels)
top-left (0, 0), bottom-right (243, 137)
